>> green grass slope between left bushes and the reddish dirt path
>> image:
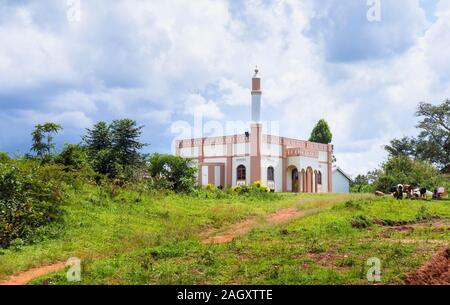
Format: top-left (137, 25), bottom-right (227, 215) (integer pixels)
top-left (0, 185), bottom-right (330, 278)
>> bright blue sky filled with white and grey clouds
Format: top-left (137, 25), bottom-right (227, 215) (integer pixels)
top-left (0, 0), bottom-right (450, 175)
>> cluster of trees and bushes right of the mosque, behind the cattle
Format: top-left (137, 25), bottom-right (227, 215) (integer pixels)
top-left (351, 100), bottom-right (450, 192)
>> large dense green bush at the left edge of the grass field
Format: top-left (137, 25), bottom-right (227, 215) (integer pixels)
top-left (0, 161), bottom-right (62, 248)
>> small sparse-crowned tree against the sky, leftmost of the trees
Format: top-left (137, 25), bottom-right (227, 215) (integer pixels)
top-left (31, 122), bottom-right (62, 158)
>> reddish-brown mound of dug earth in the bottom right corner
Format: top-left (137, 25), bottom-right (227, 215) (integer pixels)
top-left (405, 247), bottom-right (450, 285)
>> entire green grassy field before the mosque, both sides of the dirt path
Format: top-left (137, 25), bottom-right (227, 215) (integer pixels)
top-left (0, 187), bottom-right (450, 284)
